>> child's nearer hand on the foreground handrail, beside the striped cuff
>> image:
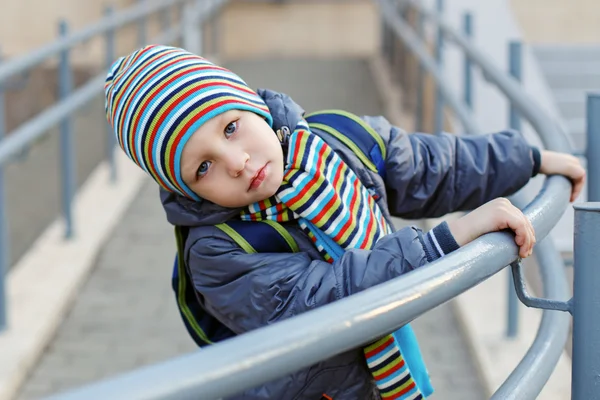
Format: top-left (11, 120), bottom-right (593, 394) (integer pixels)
top-left (448, 198), bottom-right (535, 258)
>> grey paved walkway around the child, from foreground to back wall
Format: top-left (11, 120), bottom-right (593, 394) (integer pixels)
top-left (18, 60), bottom-right (484, 400)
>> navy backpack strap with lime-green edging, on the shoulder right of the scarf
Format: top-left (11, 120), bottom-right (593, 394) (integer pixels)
top-left (305, 110), bottom-right (387, 179)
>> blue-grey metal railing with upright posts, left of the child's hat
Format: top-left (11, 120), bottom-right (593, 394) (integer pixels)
top-left (0, 0), bottom-right (226, 330)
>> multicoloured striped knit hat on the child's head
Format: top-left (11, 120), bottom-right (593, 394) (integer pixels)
top-left (104, 45), bottom-right (272, 200)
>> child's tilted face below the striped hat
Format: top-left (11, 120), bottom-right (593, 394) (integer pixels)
top-left (181, 110), bottom-right (283, 207)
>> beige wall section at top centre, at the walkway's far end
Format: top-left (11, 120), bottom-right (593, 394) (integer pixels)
top-left (220, 0), bottom-right (379, 59)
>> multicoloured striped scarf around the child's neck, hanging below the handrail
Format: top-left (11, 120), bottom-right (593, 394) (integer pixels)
top-left (241, 121), bottom-right (423, 400)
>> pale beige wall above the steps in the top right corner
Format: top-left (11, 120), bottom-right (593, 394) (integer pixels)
top-left (510, 0), bottom-right (600, 44)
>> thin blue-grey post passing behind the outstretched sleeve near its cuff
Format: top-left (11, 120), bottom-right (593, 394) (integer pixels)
top-left (506, 42), bottom-right (521, 338)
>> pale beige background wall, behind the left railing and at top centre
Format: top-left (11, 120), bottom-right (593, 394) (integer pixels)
top-left (0, 0), bottom-right (379, 65)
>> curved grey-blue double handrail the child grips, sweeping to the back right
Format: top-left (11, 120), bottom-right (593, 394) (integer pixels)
top-left (47, 0), bottom-right (570, 399)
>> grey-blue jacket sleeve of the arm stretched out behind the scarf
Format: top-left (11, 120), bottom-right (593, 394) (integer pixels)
top-left (365, 117), bottom-right (539, 218)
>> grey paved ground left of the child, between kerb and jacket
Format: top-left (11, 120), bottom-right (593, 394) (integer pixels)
top-left (15, 181), bottom-right (194, 399)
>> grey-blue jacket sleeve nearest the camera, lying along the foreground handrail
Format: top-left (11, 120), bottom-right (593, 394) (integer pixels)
top-left (187, 225), bottom-right (458, 334)
